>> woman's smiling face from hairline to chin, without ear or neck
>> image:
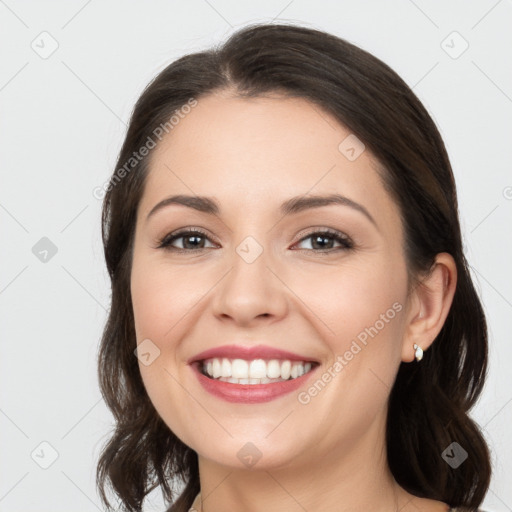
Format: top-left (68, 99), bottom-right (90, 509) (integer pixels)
top-left (131, 95), bottom-right (407, 468)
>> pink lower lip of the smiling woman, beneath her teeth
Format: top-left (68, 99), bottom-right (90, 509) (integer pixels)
top-left (191, 363), bottom-right (316, 404)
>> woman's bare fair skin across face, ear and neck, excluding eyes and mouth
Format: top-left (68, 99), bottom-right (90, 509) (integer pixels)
top-left (131, 92), bottom-right (456, 512)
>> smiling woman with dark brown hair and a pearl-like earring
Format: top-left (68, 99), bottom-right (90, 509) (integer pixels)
top-left (97, 24), bottom-right (491, 512)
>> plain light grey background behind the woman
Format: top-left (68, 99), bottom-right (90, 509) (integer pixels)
top-left (0, 0), bottom-right (512, 512)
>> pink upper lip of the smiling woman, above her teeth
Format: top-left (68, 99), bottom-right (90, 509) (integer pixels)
top-left (187, 345), bottom-right (317, 364)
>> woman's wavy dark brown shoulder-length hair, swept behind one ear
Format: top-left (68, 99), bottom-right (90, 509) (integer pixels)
top-left (97, 24), bottom-right (491, 512)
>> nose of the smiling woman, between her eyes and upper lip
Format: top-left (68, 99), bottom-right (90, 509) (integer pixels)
top-left (212, 242), bottom-right (288, 327)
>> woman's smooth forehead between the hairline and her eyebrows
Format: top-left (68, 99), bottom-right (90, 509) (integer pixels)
top-left (140, 94), bottom-right (396, 224)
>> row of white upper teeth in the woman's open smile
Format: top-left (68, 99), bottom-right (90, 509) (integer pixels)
top-left (203, 357), bottom-right (313, 384)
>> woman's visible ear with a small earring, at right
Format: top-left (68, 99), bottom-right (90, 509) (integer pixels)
top-left (402, 252), bottom-right (457, 362)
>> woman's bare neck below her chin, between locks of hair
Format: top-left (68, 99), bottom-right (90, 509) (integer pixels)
top-left (195, 412), bottom-right (408, 512)
